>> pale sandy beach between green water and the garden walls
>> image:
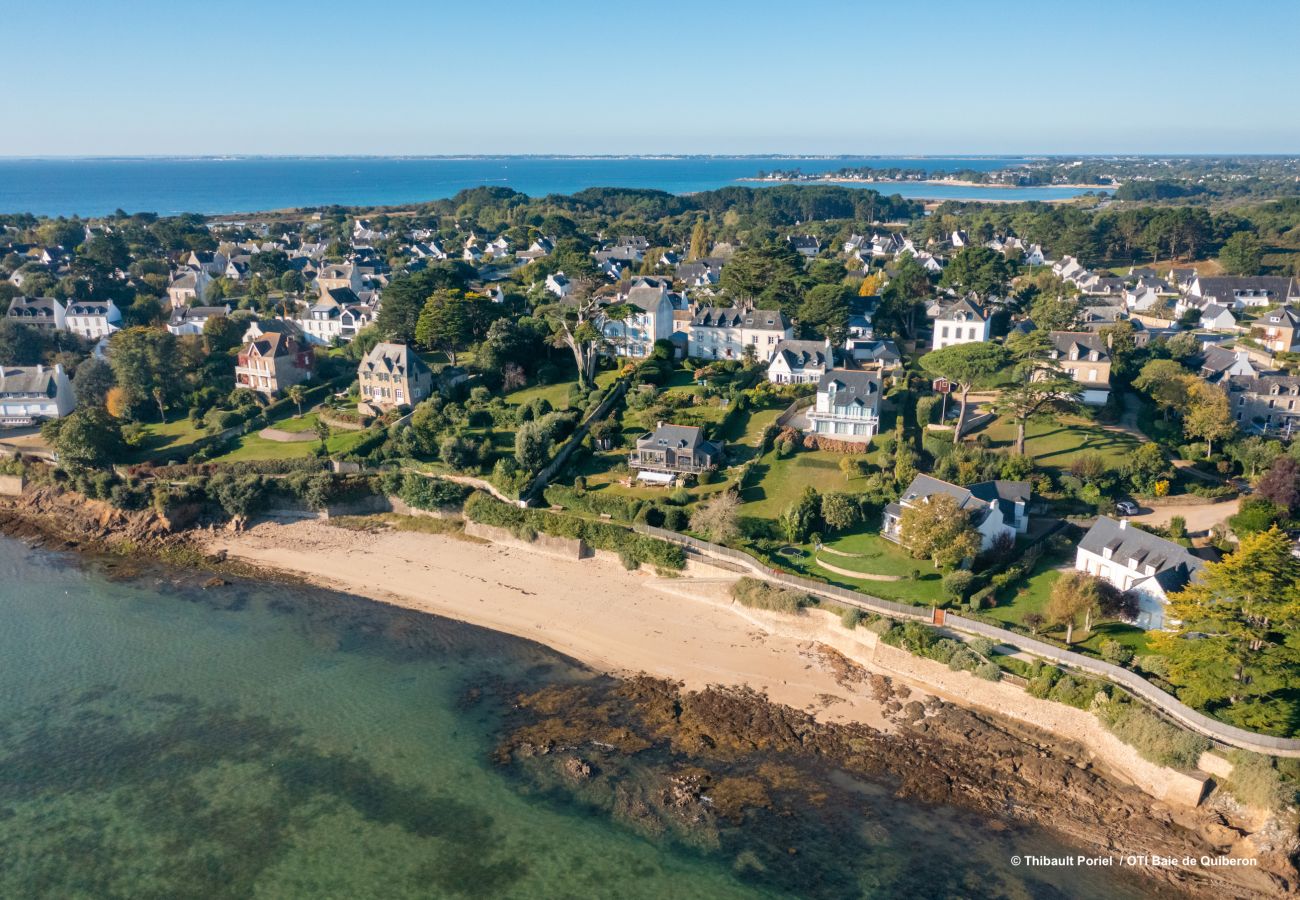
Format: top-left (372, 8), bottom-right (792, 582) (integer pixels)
top-left (207, 522), bottom-right (889, 730)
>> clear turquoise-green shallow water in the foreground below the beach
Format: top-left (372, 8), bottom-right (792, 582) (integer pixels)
top-left (0, 538), bottom-right (1159, 899)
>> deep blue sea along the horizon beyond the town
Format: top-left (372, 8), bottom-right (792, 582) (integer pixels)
top-left (0, 156), bottom-right (1107, 216)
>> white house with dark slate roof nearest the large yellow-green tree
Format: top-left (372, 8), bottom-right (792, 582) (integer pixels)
top-left (1074, 516), bottom-right (1205, 629)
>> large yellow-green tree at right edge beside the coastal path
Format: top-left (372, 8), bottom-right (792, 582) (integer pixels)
top-left (1153, 528), bottom-right (1300, 731)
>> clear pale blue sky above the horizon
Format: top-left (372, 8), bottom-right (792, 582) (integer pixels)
top-left (0, 0), bottom-right (1300, 156)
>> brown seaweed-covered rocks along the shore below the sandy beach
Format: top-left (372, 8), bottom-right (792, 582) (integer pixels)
top-left (497, 676), bottom-right (1296, 897)
